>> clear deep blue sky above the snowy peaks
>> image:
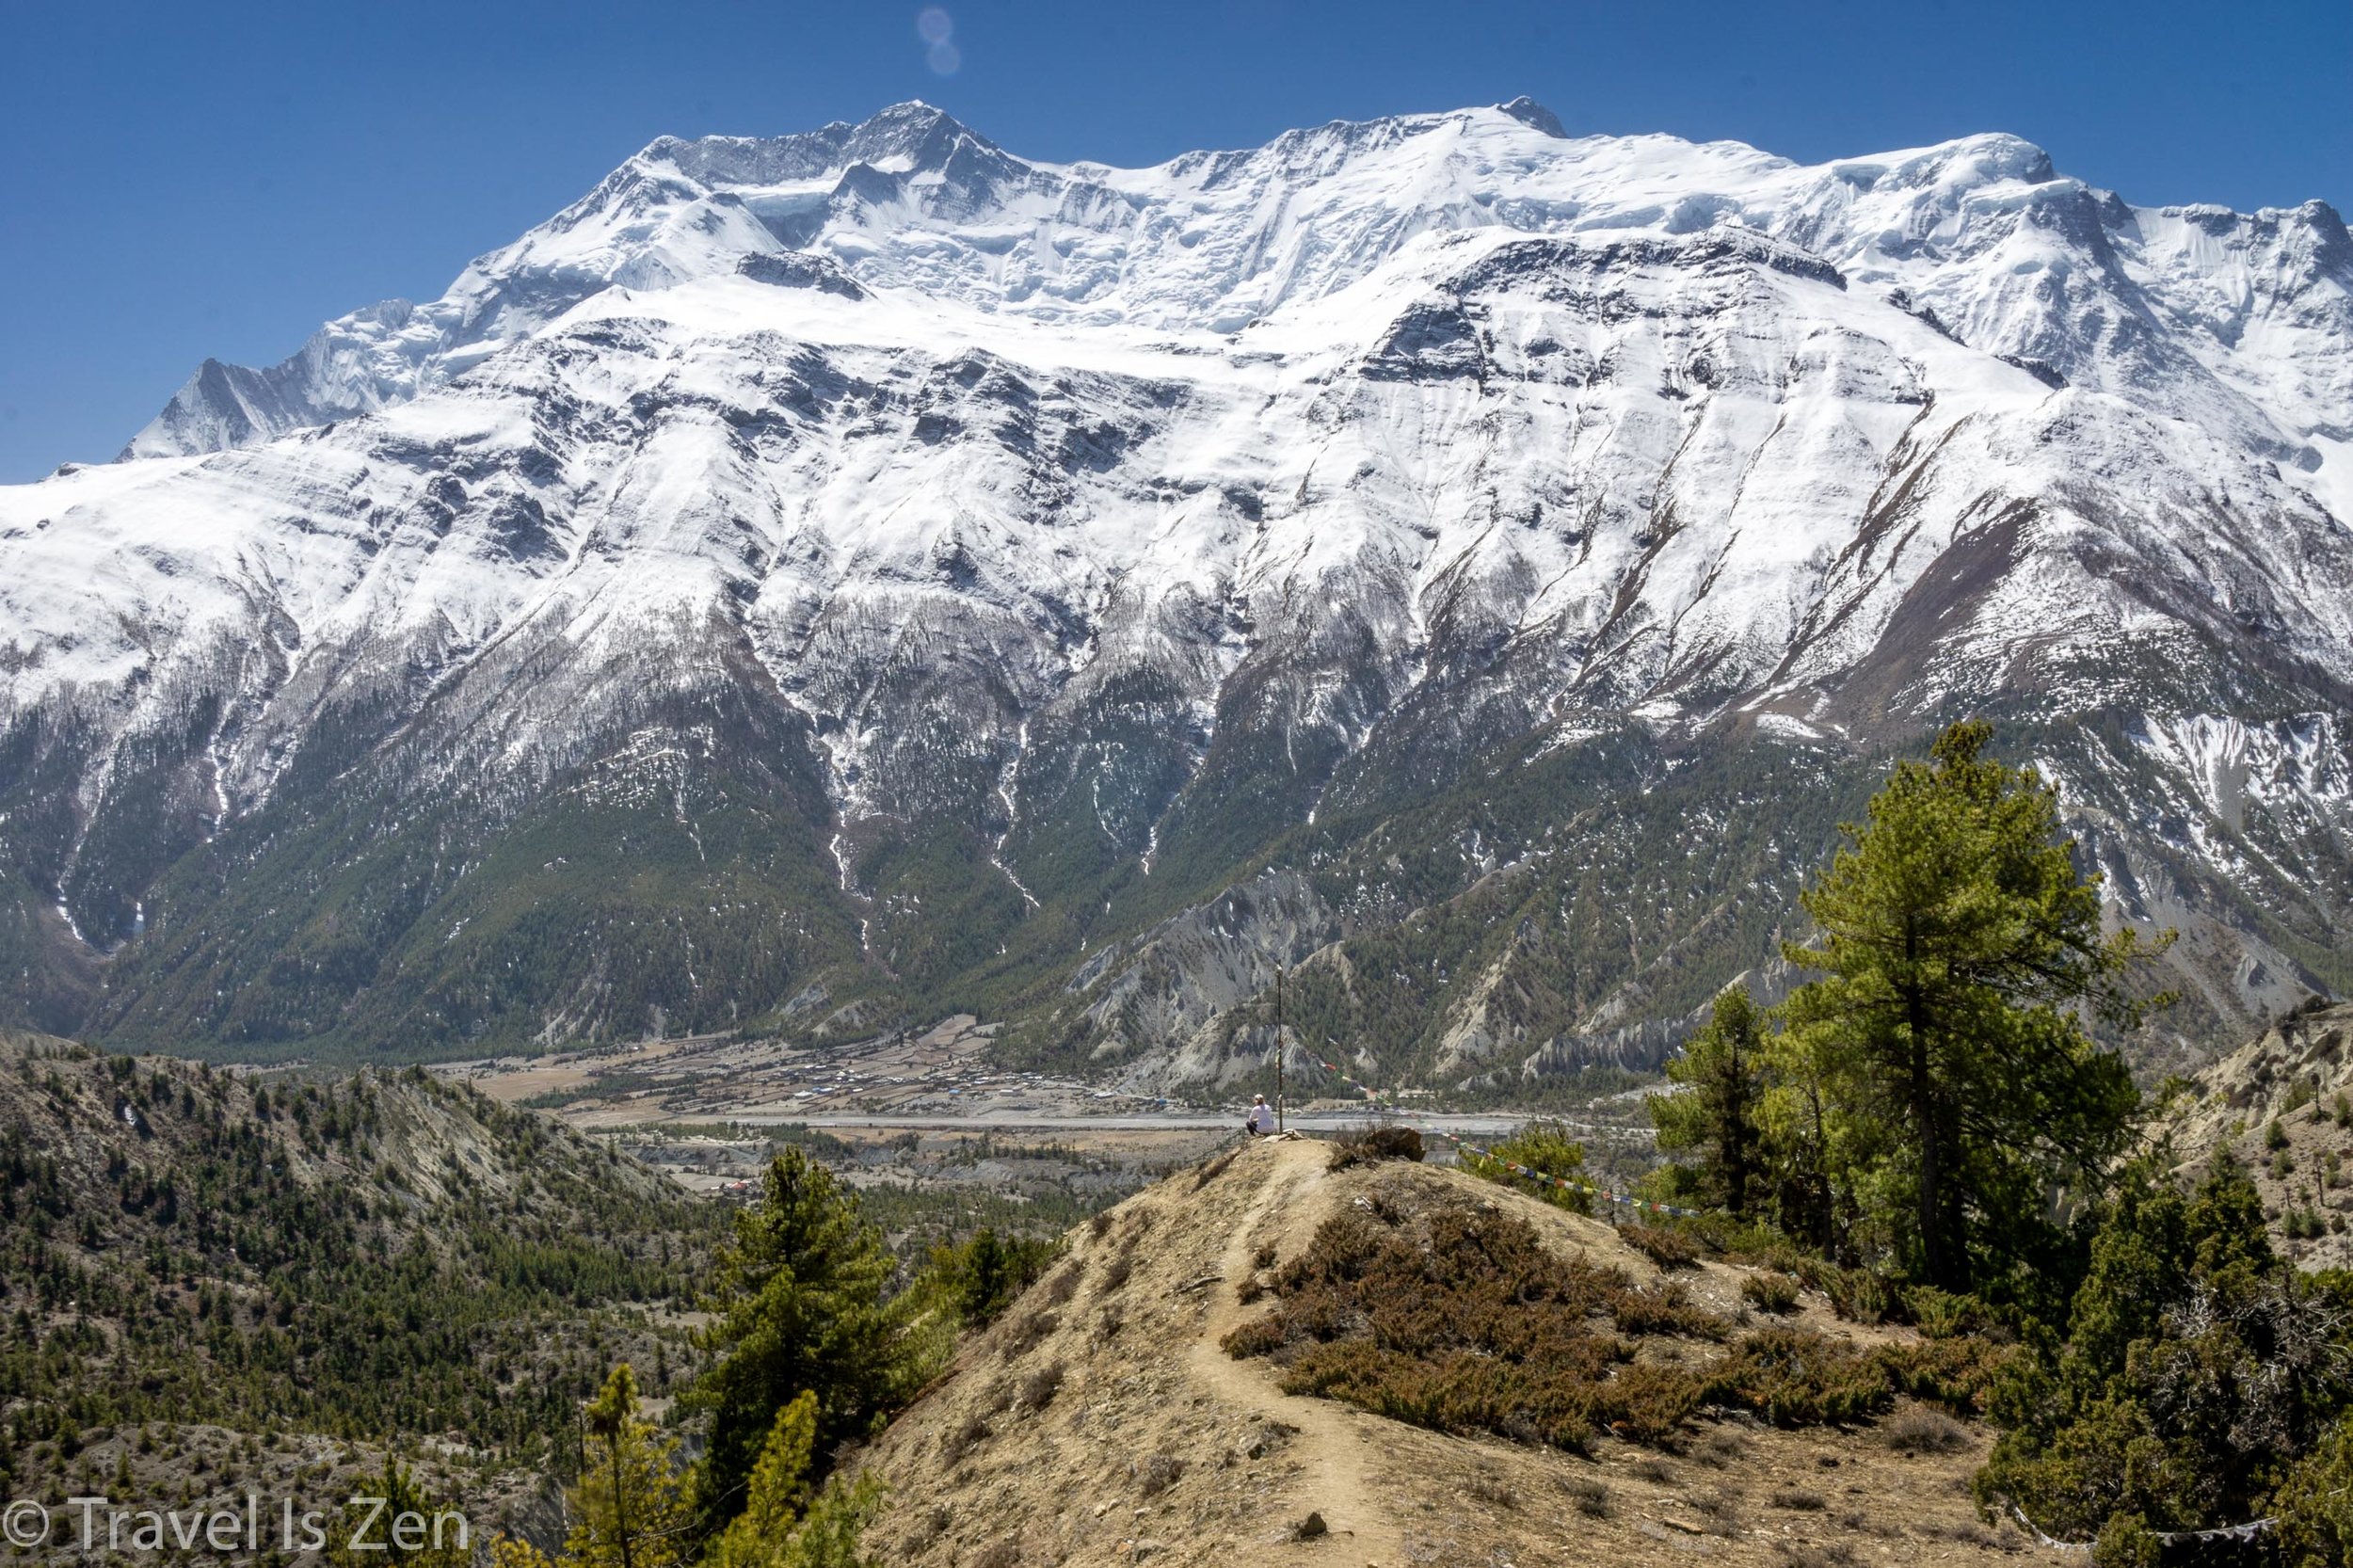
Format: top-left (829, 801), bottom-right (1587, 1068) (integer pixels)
top-left (0, 0), bottom-right (2353, 480)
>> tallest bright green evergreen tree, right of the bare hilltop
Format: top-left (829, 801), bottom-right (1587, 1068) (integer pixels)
top-left (1786, 723), bottom-right (2149, 1290)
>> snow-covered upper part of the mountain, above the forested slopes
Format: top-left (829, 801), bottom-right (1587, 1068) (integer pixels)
top-left (0, 102), bottom-right (2353, 1055)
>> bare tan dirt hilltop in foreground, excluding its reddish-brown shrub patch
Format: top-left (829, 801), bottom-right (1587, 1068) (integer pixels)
top-left (861, 1140), bottom-right (2026, 1568)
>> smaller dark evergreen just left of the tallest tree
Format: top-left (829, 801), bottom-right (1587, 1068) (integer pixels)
top-left (1647, 986), bottom-right (1768, 1220)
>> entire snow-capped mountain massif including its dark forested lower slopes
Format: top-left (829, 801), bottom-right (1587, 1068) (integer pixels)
top-left (0, 99), bottom-right (2353, 1080)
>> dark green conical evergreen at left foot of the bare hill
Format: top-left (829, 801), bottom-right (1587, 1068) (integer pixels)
top-left (692, 1149), bottom-right (913, 1532)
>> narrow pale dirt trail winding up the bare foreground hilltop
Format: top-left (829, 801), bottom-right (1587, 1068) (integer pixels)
top-left (1189, 1140), bottom-right (1407, 1568)
